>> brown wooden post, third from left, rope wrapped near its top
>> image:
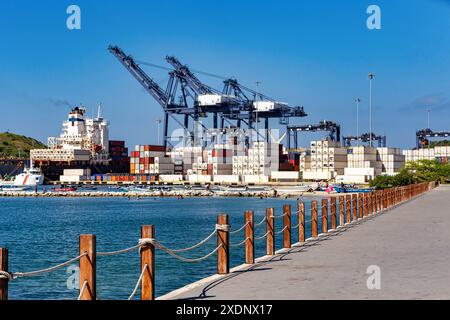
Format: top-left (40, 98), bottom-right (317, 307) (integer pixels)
top-left (141, 225), bottom-right (155, 300)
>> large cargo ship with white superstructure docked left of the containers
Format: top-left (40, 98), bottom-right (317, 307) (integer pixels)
top-left (30, 105), bottom-right (130, 182)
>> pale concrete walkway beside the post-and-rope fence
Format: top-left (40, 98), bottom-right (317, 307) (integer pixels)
top-left (161, 186), bottom-right (450, 300)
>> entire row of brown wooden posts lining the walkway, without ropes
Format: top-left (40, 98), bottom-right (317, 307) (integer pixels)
top-left (0, 183), bottom-right (434, 300)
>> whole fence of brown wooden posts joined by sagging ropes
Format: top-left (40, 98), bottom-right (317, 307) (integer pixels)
top-left (0, 184), bottom-right (434, 300)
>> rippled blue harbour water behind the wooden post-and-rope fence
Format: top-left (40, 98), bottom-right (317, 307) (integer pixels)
top-left (0, 198), bottom-right (320, 299)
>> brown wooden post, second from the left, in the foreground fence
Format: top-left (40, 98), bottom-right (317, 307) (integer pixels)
top-left (80, 234), bottom-right (97, 300)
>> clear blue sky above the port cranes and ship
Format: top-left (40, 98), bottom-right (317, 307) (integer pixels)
top-left (0, 0), bottom-right (450, 147)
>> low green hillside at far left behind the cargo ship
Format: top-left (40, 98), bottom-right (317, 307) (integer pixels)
top-left (0, 132), bottom-right (47, 159)
